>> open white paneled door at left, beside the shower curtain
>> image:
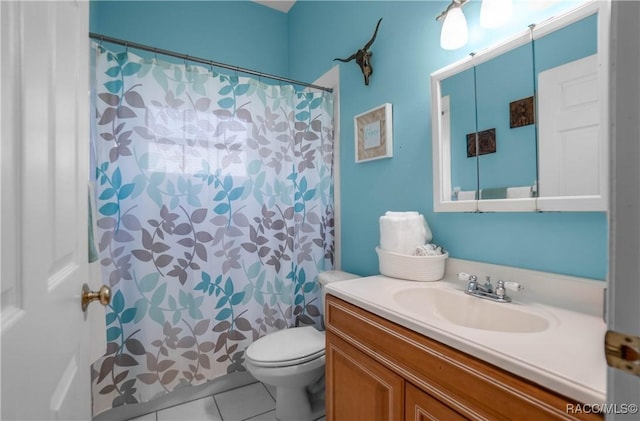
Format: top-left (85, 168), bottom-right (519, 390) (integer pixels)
top-left (0, 1), bottom-right (104, 420)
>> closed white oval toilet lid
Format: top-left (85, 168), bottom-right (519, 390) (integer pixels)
top-left (246, 326), bottom-right (325, 366)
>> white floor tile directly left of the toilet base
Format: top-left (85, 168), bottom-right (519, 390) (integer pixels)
top-left (214, 383), bottom-right (276, 421)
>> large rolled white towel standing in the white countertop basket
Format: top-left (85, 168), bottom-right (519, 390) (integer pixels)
top-left (380, 212), bottom-right (432, 255)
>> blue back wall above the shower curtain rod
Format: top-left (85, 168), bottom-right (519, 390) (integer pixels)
top-left (89, 0), bottom-right (289, 75)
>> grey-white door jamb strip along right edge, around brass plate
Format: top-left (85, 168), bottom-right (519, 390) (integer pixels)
top-left (606, 1), bottom-right (640, 420)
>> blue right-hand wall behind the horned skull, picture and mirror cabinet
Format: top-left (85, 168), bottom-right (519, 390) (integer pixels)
top-left (289, 0), bottom-right (608, 279)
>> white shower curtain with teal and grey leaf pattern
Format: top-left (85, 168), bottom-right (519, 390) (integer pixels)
top-left (92, 46), bottom-right (334, 414)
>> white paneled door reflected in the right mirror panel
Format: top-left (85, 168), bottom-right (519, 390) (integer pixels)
top-left (538, 55), bottom-right (603, 197)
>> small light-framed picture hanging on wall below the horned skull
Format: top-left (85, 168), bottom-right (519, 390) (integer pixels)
top-left (353, 103), bottom-right (393, 162)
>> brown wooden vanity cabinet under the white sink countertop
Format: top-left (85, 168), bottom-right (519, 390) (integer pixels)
top-left (325, 295), bottom-right (602, 421)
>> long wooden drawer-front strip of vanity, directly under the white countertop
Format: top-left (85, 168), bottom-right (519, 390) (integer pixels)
top-left (325, 295), bottom-right (602, 421)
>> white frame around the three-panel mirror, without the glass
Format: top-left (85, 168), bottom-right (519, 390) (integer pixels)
top-left (431, 0), bottom-right (611, 212)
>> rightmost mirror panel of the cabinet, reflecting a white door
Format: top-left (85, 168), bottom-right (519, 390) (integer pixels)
top-left (534, 7), bottom-right (608, 210)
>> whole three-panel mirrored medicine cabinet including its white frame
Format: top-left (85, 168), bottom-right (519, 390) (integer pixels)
top-left (431, 2), bottom-right (609, 212)
